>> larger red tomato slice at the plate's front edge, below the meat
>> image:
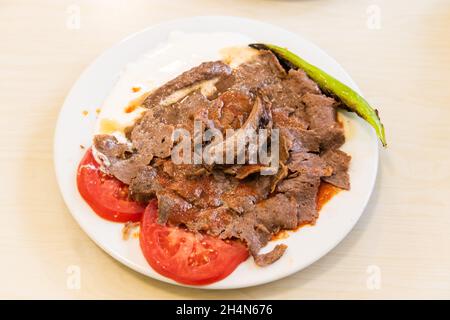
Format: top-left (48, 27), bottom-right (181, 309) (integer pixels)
top-left (139, 200), bottom-right (248, 285)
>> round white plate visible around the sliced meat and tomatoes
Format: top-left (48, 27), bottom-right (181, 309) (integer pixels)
top-left (54, 16), bottom-right (378, 289)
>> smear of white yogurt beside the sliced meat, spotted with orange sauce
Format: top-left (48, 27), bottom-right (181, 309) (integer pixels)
top-left (95, 31), bottom-right (256, 141)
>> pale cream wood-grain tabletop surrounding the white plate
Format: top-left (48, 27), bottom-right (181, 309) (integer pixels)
top-left (0, 0), bottom-right (450, 299)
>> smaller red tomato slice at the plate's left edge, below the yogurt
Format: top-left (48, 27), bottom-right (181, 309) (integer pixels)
top-left (77, 148), bottom-right (145, 222)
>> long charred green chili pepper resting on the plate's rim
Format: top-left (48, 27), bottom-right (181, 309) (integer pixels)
top-left (249, 43), bottom-right (387, 146)
